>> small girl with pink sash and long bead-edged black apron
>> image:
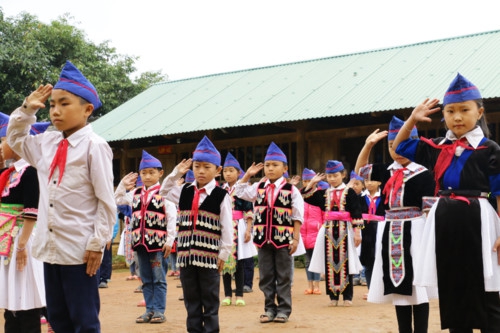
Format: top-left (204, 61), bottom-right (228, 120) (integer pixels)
top-left (302, 160), bottom-right (363, 306)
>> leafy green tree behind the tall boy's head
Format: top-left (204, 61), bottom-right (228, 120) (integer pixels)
top-left (0, 8), bottom-right (167, 120)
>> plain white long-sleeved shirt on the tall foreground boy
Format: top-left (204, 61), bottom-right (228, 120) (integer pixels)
top-left (7, 108), bottom-right (116, 265)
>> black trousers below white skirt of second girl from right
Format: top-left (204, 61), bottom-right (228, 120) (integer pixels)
top-left (396, 303), bottom-right (429, 333)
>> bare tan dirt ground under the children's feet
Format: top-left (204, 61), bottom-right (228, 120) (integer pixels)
top-left (16, 268), bottom-right (460, 333)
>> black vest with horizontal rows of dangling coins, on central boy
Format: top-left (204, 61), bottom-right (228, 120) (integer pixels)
top-left (177, 184), bottom-right (227, 269)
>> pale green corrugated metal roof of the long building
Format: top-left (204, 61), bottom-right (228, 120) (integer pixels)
top-left (92, 30), bottom-right (500, 141)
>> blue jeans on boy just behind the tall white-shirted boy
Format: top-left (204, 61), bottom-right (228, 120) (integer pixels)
top-left (137, 246), bottom-right (168, 313)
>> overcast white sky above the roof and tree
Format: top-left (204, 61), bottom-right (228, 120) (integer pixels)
top-left (0, 0), bottom-right (500, 80)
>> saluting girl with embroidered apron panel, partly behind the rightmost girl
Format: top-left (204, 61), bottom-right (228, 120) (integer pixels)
top-left (356, 117), bottom-right (437, 333)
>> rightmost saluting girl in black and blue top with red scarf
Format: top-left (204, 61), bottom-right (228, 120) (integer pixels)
top-left (394, 74), bottom-right (500, 332)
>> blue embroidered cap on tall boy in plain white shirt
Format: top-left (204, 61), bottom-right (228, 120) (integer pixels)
top-left (54, 60), bottom-right (102, 110)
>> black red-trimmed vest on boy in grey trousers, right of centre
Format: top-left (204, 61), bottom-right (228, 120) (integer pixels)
top-left (253, 182), bottom-right (293, 248)
